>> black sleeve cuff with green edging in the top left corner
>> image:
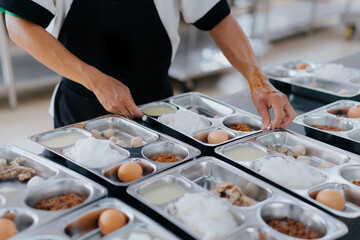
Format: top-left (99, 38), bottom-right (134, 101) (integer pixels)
top-left (0, 0), bottom-right (56, 28)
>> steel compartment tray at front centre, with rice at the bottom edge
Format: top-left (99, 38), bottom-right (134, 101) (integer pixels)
top-left (127, 157), bottom-right (347, 239)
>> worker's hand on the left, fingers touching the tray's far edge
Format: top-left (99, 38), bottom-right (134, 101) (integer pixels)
top-left (92, 76), bottom-right (144, 118)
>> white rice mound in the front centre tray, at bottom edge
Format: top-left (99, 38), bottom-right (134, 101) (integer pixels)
top-left (168, 193), bottom-right (237, 239)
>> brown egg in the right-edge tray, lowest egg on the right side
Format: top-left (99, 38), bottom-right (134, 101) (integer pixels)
top-left (315, 189), bottom-right (345, 211)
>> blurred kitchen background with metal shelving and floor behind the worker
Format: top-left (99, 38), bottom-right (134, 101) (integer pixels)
top-left (0, 0), bottom-right (360, 152)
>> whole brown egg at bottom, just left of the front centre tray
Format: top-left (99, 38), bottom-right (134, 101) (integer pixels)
top-left (98, 209), bottom-right (127, 235)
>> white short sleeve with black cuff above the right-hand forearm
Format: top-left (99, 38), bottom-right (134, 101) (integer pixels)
top-left (180, 0), bottom-right (230, 31)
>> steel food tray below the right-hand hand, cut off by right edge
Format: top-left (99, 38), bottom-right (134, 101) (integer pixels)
top-left (215, 130), bottom-right (360, 218)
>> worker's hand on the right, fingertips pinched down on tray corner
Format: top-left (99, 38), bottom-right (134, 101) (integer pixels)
top-left (250, 79), bottom-right (296, 130)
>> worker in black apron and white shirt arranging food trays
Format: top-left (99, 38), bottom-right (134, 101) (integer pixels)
top-left (0, 0), bottom-right (295, 129)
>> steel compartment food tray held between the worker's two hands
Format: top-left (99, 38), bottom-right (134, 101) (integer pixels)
top-left (140, 92), bottom-right (262, 150)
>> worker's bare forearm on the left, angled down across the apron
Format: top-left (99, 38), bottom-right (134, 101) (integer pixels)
top-left (6, 14), bottom-right (105, 90)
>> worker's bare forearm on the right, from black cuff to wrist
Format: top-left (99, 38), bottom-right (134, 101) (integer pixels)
top-left (210, 15), bottom-right (269, 90)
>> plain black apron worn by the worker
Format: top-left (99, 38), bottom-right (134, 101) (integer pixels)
top-left (54, 0), bottom-right (173, 128)
